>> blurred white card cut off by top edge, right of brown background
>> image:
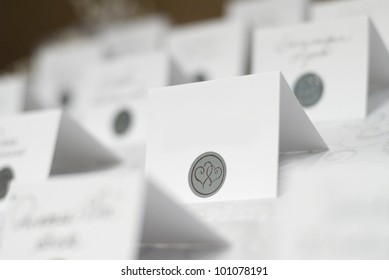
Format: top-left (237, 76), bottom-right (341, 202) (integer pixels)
top-left (226, 0), bottom-right (308, 28)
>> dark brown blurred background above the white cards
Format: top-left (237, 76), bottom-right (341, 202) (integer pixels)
top-left (0, 0), bottom-right (331, 73)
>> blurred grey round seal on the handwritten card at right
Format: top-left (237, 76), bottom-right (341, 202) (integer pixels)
top-left (294, 73), bottom-right (324, 107)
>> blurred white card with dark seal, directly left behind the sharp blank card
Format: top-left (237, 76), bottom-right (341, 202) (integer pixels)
top-left (72, 51), bottom-right (170, 151)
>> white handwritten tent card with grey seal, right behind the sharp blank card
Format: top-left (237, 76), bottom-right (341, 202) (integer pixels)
top-left (253, 17), bottom-right (389, 121)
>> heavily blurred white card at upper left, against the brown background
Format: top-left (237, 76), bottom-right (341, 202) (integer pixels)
top-left (29, 40), bottom-right (101, 109)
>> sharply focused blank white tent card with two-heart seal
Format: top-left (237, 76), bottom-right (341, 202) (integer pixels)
top-left (146, 72), bottom-right (327, 203)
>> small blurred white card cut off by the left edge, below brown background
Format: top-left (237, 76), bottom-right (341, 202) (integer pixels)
top-left (0, 75), bottom-right (26, 115)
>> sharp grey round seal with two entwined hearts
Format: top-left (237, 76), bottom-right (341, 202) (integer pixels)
top-left (188, 152), bottom-right (227, 197)
